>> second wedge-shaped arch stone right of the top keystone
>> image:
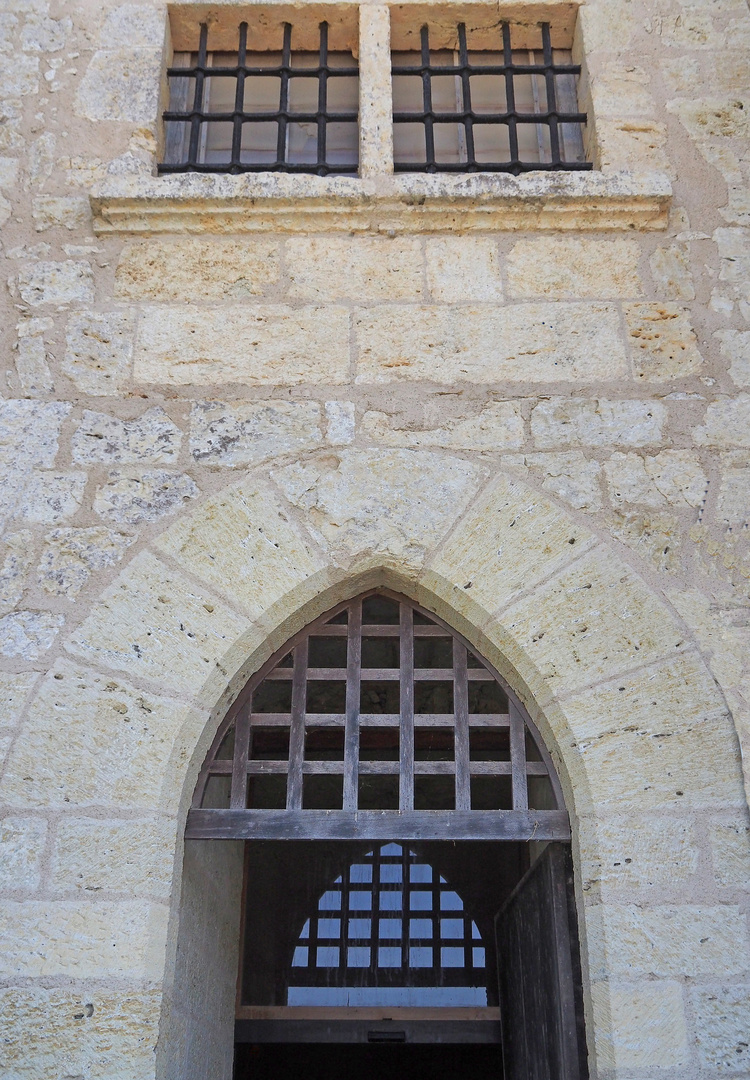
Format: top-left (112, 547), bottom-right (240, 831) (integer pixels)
top-left (503, 546), bottom-right (683, 693)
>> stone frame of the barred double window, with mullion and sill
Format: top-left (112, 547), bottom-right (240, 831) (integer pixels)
top-left (90, 0), bottom-right (671, 235)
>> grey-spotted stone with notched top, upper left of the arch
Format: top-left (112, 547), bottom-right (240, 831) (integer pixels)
top-left (72, 405), bottom-right (183, 464)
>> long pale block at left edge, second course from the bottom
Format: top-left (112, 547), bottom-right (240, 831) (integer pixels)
top-left (0, 900), bottom-right (169, 982)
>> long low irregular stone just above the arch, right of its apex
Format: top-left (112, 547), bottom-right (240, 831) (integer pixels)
top-left (362, 402), bottom-right (524, 450)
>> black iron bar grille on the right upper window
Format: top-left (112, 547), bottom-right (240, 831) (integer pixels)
top-left (392, 23), bottom-right (591, 175)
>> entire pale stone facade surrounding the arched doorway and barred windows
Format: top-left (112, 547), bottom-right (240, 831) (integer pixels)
top-left (0, 0), bottom-right (750, 1080)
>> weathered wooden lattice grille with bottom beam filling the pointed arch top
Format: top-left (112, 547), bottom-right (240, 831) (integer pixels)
top-left (188, 591), bottom-right (570, 839)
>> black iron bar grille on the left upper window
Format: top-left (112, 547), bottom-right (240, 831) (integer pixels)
top-left (164, 23), bottom-right (359, 176)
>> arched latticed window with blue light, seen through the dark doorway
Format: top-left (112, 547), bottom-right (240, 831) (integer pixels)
top-left (287, 843), bottom-right (486, 1005)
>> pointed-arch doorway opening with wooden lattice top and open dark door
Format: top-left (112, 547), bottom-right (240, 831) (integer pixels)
top-left (186, 590), bottom-right (586, 1080)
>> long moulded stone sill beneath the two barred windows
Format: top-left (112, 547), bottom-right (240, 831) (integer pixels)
top-left (90, 172), bottom-right (672, 234)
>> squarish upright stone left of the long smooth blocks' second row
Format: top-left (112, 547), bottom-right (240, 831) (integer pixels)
top-left (62, 311), bottom-right (133, 395)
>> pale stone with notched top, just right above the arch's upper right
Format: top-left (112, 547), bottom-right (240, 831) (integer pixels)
top-left (604, 450), bottom-right (708, 507)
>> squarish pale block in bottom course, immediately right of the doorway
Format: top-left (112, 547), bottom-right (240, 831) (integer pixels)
top-left (592, 980), bottom-right (689, 1071)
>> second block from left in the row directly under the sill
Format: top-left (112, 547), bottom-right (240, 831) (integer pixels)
top-left (285, 237), bottom-right (424, 303)
